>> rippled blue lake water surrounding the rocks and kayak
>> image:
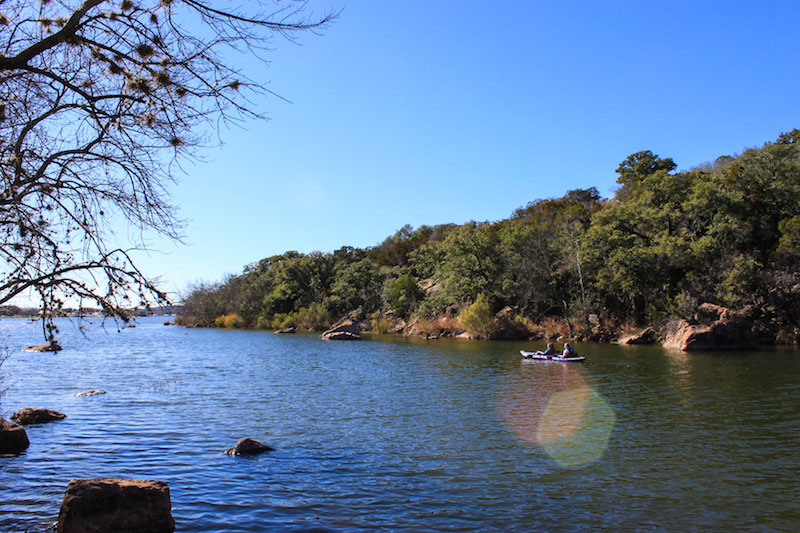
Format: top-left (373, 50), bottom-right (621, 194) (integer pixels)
top-left (0, 318), bottom-right (800, 531)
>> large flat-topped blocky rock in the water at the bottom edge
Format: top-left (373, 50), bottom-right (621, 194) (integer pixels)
top-left (57, 478), bottom-right (175, 533)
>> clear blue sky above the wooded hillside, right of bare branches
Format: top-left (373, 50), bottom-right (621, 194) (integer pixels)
top-left (139, 0), bottom-right (800, 300)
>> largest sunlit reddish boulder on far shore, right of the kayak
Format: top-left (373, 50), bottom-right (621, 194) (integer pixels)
top-left (663, 303), bottom-right (755, 352)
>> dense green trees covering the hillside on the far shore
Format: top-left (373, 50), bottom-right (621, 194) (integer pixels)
top-left (184, 130), bottom-right (800, 340)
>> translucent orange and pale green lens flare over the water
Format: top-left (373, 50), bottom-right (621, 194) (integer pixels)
top-left (499, 361), bottom-right (615, 467)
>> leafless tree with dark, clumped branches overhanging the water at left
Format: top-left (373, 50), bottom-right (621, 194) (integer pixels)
top-left (0, 0), bottom-right (335, 341)
